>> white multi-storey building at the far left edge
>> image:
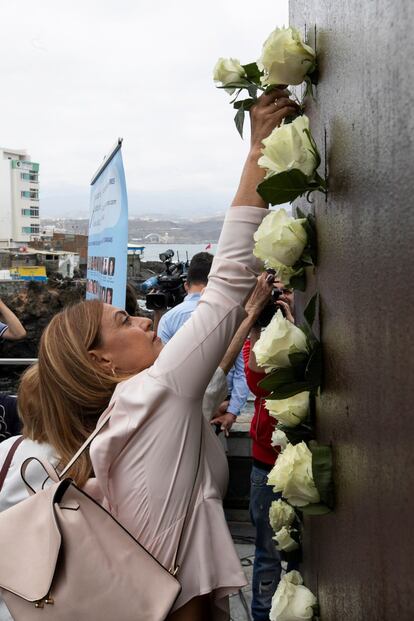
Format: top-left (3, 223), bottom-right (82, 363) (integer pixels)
top-left (0, 148), bottom-right (40, 248)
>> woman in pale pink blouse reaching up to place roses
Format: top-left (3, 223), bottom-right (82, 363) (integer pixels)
top-left (19, 89), bottom-right (296, 621)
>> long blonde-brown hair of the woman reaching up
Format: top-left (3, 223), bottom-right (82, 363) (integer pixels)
top-left (18, 300), bottom-right (125, 486)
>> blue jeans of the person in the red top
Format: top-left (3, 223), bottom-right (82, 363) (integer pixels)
top-left (250, 466), bottom-right (281, 621)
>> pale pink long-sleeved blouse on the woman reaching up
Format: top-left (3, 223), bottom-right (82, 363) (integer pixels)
top-left (91, 207), bottom-right (266, 621)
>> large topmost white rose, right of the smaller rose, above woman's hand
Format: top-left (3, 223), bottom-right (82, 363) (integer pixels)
top-left (257, 28), bottom-right (316, 84)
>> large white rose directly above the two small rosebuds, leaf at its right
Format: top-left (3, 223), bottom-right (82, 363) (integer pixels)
top-left (267, 442), bottom-right (320, 507)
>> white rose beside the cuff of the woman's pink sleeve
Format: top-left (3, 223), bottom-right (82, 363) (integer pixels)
top-left (253, 209), bottom-right (308, 269)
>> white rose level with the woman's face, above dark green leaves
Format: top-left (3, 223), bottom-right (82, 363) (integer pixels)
top-left (253, 311), bottom-right (307, 372)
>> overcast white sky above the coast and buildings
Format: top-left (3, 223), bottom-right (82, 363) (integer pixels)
top-left (0, 0), bottom-right (288, 215)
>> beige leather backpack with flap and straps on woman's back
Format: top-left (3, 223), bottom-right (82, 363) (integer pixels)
top-left (0, 404), bottom-right (201, 621)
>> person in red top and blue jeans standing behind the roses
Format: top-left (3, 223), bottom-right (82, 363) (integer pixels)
top-left (243, 290), bottom-right (294, 621)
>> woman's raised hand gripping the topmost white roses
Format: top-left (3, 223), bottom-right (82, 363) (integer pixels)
top-left (250, 88), bottom-right (299, 158)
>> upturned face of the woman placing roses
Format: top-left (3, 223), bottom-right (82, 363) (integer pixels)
top-left (93, 304), bottom-right (163, 373)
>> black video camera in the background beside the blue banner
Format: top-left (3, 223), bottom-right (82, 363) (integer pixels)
top-left (141, 249), bottom-right (188, 310)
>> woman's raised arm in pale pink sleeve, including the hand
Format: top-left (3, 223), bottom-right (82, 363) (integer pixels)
top-left (149, 89), bottom-right (297, 399)
